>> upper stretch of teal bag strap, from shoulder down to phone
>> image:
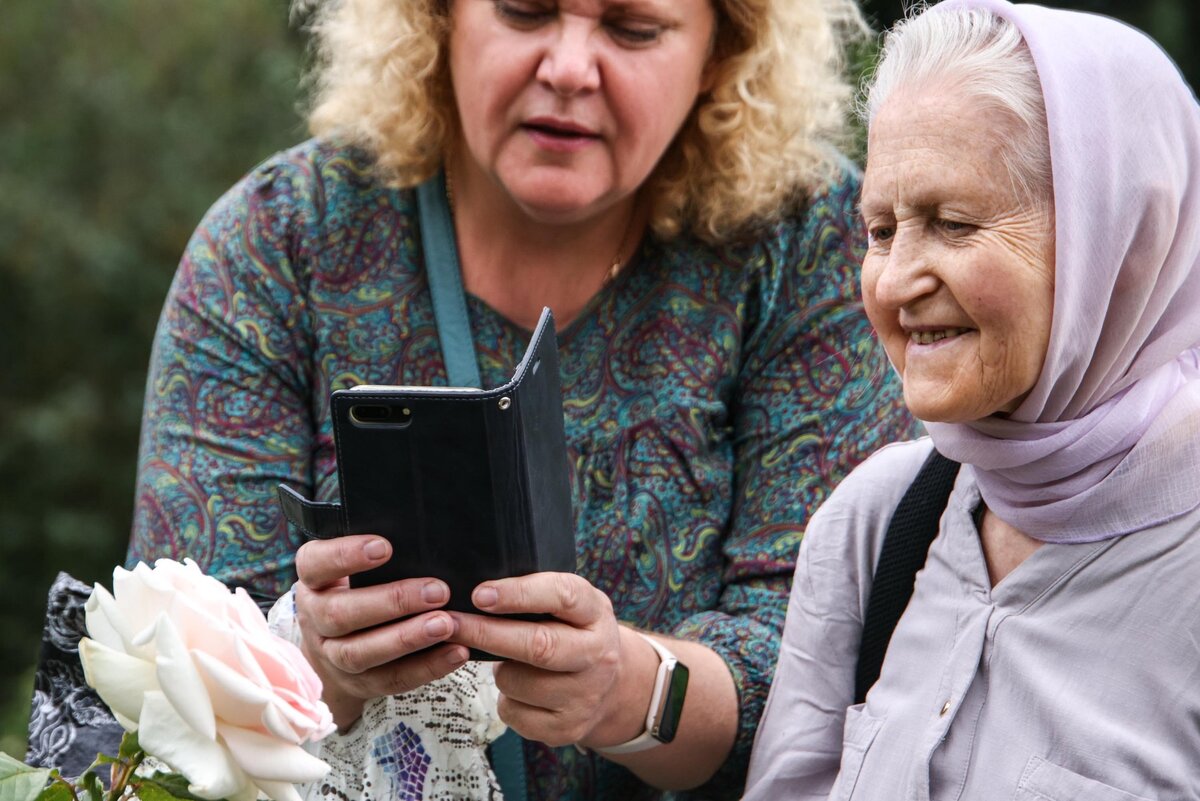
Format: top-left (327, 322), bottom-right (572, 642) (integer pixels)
top-left (416, 170), bottom-right (484, 390)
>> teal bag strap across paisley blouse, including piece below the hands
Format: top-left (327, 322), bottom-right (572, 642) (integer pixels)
top-left (416, 170), bottom-right (529, 801)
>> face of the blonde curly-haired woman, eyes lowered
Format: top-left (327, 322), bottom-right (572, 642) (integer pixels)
top-left (450, 0), bottom-right (715, 222)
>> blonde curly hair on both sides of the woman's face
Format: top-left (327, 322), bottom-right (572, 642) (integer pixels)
top-left (296, 0), bottom-right (866, 241)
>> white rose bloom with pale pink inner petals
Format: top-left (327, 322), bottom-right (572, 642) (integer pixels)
top-left (79, 559), bottom-right (335, 801)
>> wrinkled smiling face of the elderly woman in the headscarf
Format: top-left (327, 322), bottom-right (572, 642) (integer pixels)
top-left (863, 90), bottom-right (1054, 422)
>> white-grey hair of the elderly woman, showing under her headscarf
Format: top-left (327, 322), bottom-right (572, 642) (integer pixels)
top-left (858, 4), bottom-right (1054, 209)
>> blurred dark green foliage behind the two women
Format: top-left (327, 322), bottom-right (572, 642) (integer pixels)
top-left (0, 0), bottom-right (1198, 757)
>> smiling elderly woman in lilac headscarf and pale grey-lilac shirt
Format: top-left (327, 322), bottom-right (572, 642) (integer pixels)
top-left (746, 0), bottom-right (1200, 801)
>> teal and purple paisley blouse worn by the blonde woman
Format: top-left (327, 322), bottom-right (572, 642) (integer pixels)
top-left (128, 140), bottom-right (911, 801)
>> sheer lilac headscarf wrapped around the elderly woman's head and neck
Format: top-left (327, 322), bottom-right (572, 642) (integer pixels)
top-left (928, 0), bottom-right (1200, 542)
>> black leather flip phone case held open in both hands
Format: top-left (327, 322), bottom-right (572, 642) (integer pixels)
top-left (280, 309), bottom-right (575, 613)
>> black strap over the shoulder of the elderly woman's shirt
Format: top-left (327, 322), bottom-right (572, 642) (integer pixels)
top-left (854, 451), bottom-right (959, 704)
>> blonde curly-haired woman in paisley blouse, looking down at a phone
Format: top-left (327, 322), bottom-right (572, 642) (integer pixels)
top-left (130, 0), bottom-right (910, 801)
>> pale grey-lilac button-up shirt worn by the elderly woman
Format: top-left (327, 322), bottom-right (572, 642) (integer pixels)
top-left (745, 439), bottom-right (1200, 801)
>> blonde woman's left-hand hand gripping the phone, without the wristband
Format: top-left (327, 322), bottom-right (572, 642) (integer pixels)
top-left (295, 535), bottom-right (468, 730)
